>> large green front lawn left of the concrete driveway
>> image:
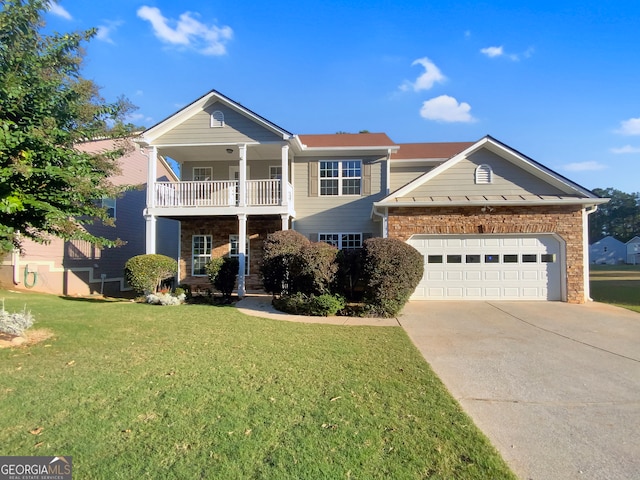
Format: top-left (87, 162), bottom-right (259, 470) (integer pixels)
top-left (0, 292), bottom-right (515, 479)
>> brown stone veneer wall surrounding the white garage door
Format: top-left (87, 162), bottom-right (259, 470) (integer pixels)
top-left (388, 205), bottom-right (585, 303)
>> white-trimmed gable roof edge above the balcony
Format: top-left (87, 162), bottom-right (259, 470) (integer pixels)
top-left (140, 90), bottom-right (293, 144)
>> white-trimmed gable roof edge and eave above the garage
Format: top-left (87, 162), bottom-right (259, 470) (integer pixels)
top-left (374, 135), bottom-right (608, 207)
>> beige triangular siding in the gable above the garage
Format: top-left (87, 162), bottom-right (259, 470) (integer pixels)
top-left (408, 150), bottom-right (564, 197)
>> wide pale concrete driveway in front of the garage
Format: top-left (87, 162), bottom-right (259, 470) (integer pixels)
top-left (399, 301), bottom-right (640, 480)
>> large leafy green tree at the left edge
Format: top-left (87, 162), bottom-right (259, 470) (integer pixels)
top-left (0, 0), bottom-right (138, 254)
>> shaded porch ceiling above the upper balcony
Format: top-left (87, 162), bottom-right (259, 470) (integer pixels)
top-left (158, 144), bottom-right (282, 163)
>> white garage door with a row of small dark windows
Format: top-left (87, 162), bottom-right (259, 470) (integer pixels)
top-left (408, 235), bottom-right (562, 300)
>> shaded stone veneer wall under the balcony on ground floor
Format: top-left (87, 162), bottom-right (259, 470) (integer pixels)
top-left (180, 216), bottom-right (282, 291)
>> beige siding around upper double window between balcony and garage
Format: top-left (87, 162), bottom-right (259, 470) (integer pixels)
top-left (293, 156), bottom-right (385, 239)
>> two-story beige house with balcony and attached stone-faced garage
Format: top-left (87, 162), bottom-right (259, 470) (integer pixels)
top-left (138, 90), bottom-right (607, 303)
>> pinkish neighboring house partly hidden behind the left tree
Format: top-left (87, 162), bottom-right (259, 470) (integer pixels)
top-left (0, 140), bottom-right (178, 295)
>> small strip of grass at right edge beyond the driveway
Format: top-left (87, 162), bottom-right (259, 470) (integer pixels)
top-left (590, 265), bottom-right (640, 312)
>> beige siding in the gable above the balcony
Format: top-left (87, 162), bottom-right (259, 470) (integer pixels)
top-left (154, 102), bottom-right (282, 145)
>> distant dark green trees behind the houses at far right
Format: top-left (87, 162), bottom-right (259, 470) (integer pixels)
top-left (589, 188), bottom-right (640, 243)
